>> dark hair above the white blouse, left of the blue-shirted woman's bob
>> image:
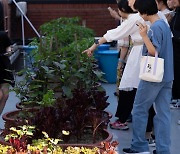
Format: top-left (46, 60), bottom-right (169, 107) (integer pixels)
top-left (118, 0), bottom-right (135, 13)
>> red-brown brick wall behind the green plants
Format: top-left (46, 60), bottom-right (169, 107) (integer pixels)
top-left (11, 4), bottom-right (117, 39)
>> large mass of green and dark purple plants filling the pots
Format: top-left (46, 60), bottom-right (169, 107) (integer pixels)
top-left (3, 18), bottom-right (112, 149)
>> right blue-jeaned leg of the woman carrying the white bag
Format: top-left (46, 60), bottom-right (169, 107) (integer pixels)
top-left (154, 83), bottom-right (172, 154)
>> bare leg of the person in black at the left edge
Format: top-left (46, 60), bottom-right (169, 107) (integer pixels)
top-left (0, 83), bottom-right (9, 115)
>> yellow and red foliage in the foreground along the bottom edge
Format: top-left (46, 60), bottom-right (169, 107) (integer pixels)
top-left (0, 125), bottom-right (118, 154)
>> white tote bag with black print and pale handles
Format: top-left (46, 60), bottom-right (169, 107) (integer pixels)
top-left (139, 51), bottom-right (164, 82)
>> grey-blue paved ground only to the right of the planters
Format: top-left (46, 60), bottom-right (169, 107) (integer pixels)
top-left (103, 84), bottom-right (180, 154)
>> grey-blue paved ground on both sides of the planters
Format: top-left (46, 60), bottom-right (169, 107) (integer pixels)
top-left (0, 84), bottom-right (180, 154)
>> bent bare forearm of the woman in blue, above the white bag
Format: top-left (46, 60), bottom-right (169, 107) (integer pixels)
top-left (138, 23), bottom-right (156, 56)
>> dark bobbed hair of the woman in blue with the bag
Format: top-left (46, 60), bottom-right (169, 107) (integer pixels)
top-left (134, 0), bottom-right (158, 15)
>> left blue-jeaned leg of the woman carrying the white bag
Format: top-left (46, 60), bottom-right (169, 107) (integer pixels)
top-left (131, 81), bottom-right (162, 152)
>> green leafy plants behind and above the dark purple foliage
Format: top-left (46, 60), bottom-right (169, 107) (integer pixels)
top-left (15, 17), bottom-right (103, 103)
